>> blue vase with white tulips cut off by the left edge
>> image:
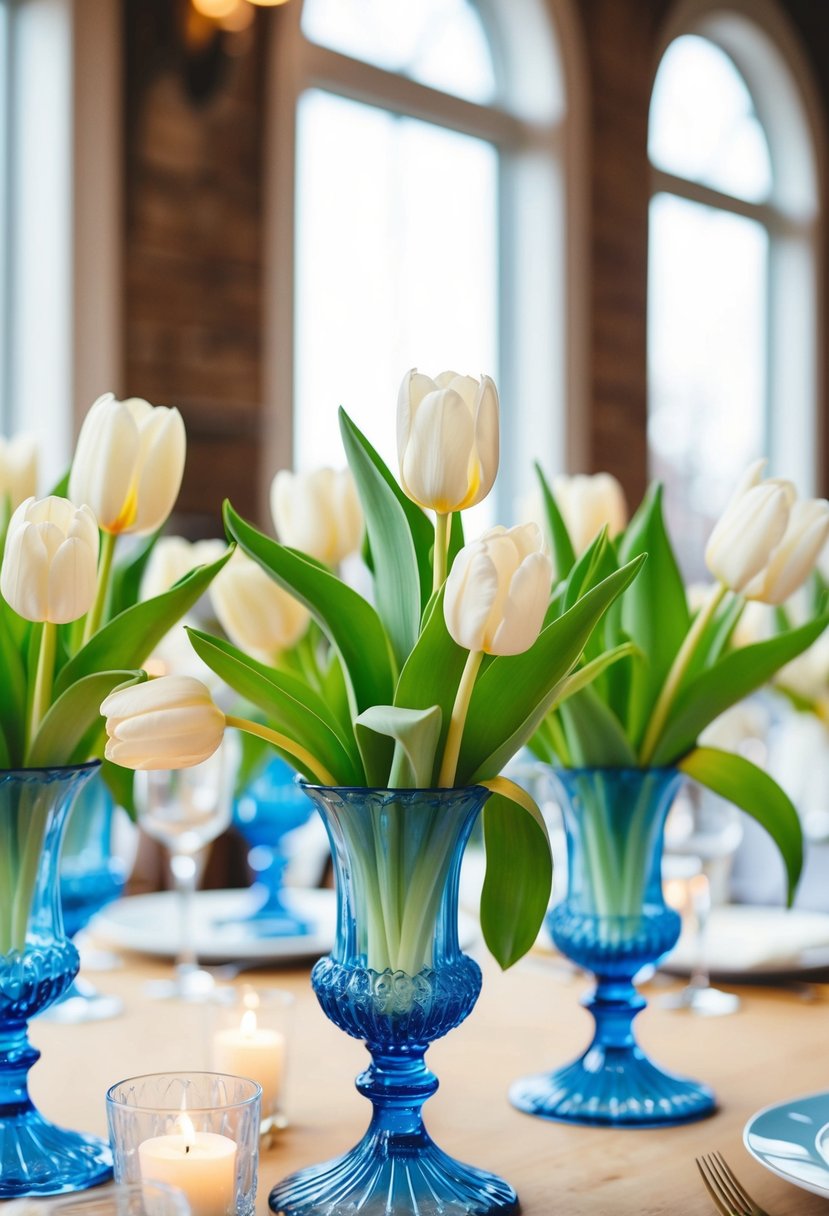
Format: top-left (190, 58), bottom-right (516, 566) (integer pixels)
top-left (0, 394), bottom-right (226, 1198)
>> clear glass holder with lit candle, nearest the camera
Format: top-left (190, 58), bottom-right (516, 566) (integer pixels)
top-left (107, 1073), bottom-right (261, 1216)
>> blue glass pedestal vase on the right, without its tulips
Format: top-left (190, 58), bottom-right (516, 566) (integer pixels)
top-left (509, 769), bottom-right (715, 1127)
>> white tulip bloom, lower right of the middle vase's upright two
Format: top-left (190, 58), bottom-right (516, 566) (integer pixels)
top-left (444, 524), bottom-right (553, 654)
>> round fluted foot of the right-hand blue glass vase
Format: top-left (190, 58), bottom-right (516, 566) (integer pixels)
top-left (509, 1045), bottom-right (716, 1127)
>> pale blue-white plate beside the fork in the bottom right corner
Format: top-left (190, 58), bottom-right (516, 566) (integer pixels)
top-left (743, 1093), bottom-right (829, 1198)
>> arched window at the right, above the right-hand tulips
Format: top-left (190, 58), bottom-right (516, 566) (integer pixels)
top-left (648, 4), bottom-right (818, 576)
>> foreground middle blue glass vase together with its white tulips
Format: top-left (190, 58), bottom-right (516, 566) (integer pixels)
top-left (102, 372), bottom-right (643, 1216)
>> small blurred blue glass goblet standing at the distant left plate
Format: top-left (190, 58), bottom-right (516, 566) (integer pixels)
top-left (233, 756), bottom-right (314, 938)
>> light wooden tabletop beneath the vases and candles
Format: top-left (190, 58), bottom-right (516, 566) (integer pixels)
top-left (32, 956), bottom-right (829, 1216)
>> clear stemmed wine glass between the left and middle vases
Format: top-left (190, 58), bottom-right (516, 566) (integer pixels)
top-left (135, 734), bottom-right (236, 1001)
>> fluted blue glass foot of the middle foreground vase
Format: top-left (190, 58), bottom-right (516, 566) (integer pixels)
top-left (269, 1132), bottom-right (518, 1216)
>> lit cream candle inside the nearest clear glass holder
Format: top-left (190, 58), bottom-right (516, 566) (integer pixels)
top-left (139, 1115), bottom-right (237, 1216)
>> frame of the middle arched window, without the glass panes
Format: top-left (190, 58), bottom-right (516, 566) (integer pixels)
top-left (259, 0), bottom-right (587, 518)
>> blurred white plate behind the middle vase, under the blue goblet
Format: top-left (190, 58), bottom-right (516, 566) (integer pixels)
top-left (89, 886), bottom-right (337, 963)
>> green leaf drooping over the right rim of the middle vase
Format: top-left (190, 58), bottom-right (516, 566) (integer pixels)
top-left (480, 777), bottom-right (553, 970)
